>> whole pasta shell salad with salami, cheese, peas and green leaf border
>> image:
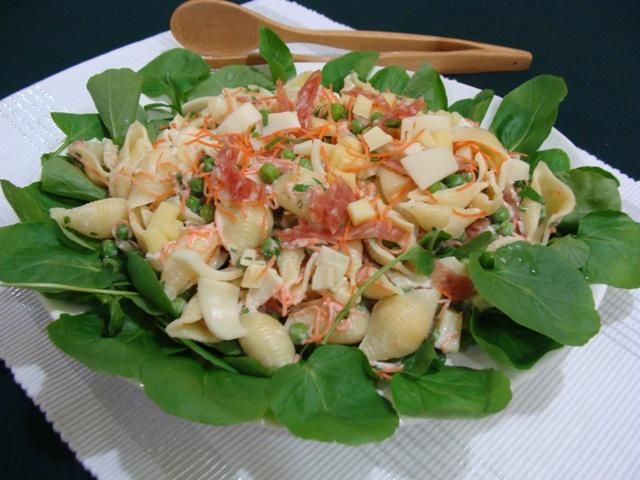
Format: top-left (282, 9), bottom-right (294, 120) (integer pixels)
top-left (0, 28), bottom-right (640, 444)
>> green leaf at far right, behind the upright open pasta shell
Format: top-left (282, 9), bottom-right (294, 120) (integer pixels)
top-left (556, 167), bottom-right (621, 232)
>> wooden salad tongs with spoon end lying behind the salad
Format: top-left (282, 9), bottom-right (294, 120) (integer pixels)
top-left (171, 0), bottom-right (531, 73)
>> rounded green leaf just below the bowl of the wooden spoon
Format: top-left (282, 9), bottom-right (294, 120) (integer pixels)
top-left (138, 48), bottom-right (210, 111)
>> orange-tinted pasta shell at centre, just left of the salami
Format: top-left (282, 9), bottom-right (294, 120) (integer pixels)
top-left (215, 206), bottom-right (273, 265)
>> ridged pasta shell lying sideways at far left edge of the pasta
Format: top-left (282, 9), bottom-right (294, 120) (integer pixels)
top-left (49, 198), bottom-right (128, 239)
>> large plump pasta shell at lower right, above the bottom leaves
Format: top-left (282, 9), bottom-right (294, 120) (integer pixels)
top-left (360, 289), bottom-right (440, 360)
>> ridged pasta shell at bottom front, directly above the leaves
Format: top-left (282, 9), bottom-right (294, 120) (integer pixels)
top-left (239, 312), bottom-right (296, 368)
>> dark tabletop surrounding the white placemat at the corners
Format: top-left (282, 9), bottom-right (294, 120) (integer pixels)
top-left (0, 0), bottom-right (640, 479)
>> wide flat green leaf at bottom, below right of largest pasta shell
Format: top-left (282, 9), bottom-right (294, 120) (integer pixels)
top-left (391, 366), bottom-right (511, 417)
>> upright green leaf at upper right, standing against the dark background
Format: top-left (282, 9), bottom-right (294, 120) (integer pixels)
top-left (491, 75), bottom-right (567, 155)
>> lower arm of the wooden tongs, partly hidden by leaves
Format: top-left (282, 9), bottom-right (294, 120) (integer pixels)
top-left (204, 49), bottom-right (531, 74)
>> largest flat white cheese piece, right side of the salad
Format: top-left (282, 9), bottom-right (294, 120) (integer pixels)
top-left (400, 147), bottom-right (458, 190)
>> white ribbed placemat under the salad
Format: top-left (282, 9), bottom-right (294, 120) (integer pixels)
top-left (0, 0), bottom-right (640, 479)
